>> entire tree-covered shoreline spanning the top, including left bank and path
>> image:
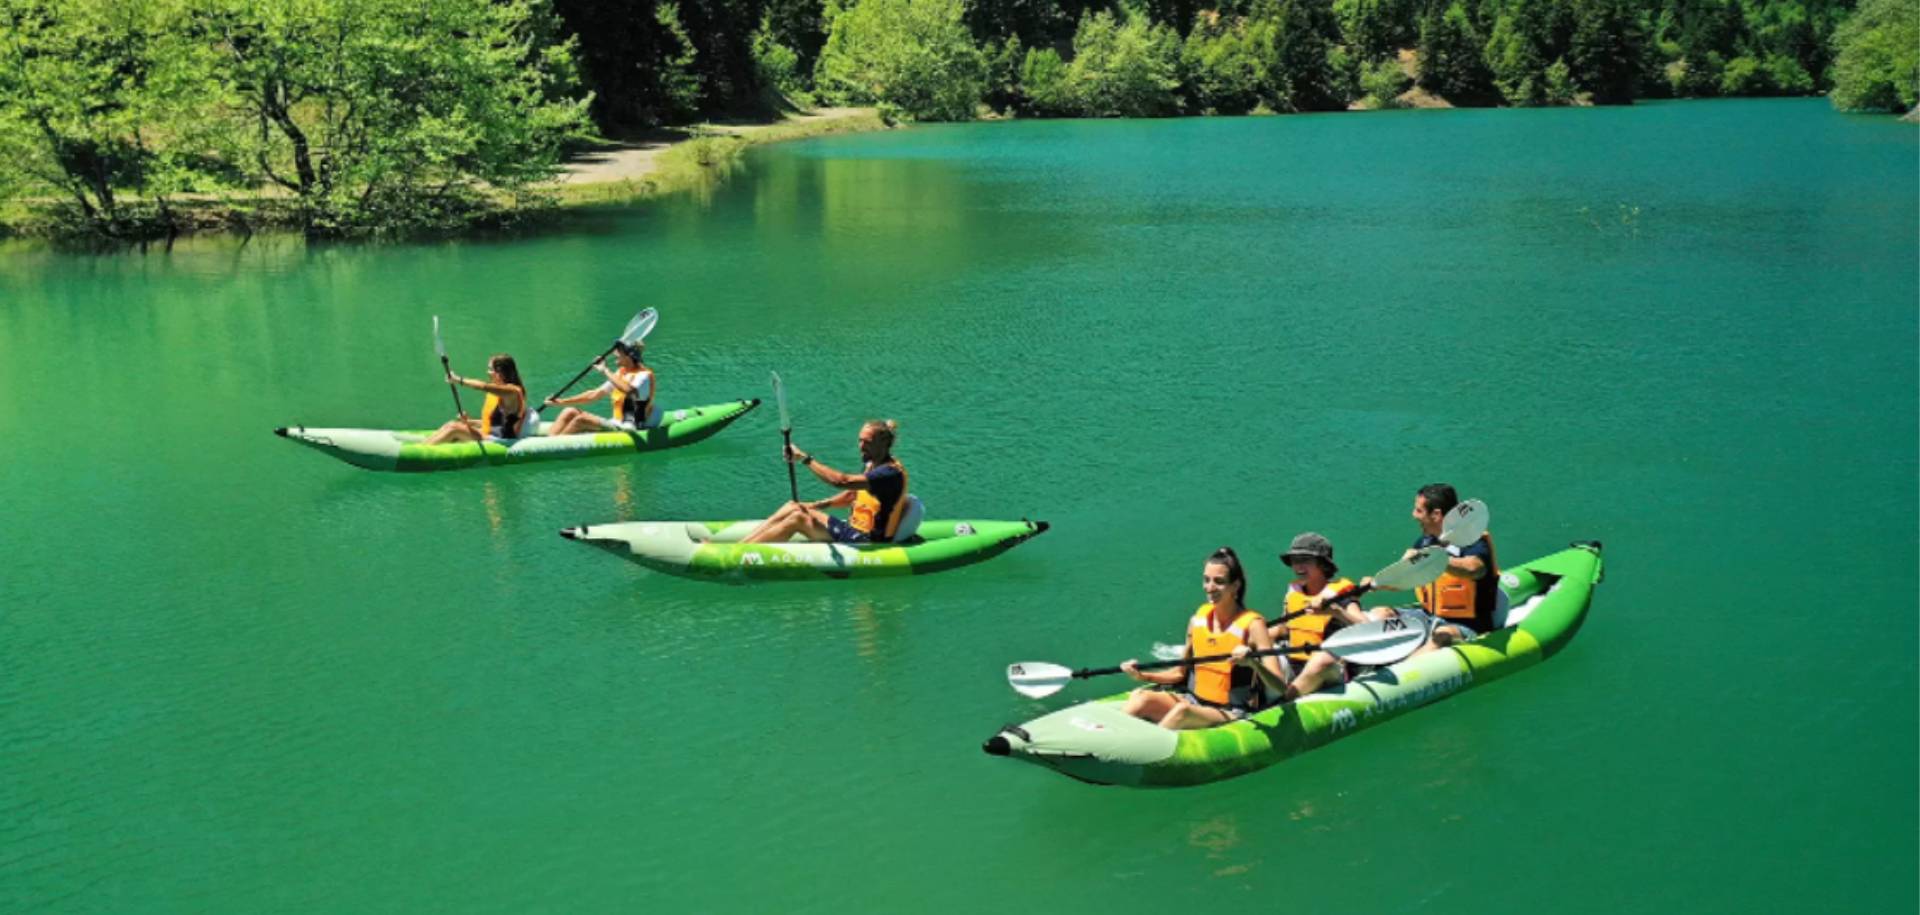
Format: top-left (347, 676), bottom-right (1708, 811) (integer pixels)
top-left (0, 0), bottom-right (1920, 238)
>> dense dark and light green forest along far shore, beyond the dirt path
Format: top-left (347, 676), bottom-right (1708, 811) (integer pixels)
top-left (555, 0), bottom-right (1920, 129)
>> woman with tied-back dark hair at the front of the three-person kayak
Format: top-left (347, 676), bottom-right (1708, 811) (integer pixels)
top-left (1119, 547), bottom-right (1286, 731)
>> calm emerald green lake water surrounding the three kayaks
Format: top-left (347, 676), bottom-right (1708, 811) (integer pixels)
top-left (0, 100), bottom-right (1920, 913)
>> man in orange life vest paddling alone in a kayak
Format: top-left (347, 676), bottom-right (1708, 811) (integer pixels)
top-left (741, 420), bottom-right (906, 543)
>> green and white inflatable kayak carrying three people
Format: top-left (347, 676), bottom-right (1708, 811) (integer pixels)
top-left (985, 543), bottom-right (1603, 786)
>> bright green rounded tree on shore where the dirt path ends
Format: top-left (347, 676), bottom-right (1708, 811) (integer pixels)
top-left (814, 0), bottom-right (987, 121)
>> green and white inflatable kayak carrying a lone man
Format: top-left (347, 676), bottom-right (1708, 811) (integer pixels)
top-left (561, 522), bottom-right (1046, 581)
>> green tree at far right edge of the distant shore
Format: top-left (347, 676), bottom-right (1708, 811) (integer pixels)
top-left (1828, 0), bottom-right (1920, 111)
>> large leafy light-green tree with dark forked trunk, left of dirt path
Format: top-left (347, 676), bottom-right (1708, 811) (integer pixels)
top-left (198, 0), bottom-right (588, 234)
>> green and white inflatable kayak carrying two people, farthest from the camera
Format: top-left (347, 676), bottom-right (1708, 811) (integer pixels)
top-left (273, 397), bottom-right (760, 472)
